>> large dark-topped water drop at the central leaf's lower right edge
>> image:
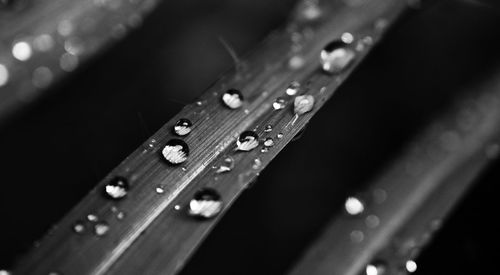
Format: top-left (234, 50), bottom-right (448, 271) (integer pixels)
top-left (188, 188), bottom-right (223, 219)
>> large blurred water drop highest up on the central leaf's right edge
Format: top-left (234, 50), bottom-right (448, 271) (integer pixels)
top-left (320, 40), bottom-right (356, 74)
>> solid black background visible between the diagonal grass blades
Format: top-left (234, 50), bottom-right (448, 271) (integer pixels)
top-left (0, 0), bottom-right (500, 275)
